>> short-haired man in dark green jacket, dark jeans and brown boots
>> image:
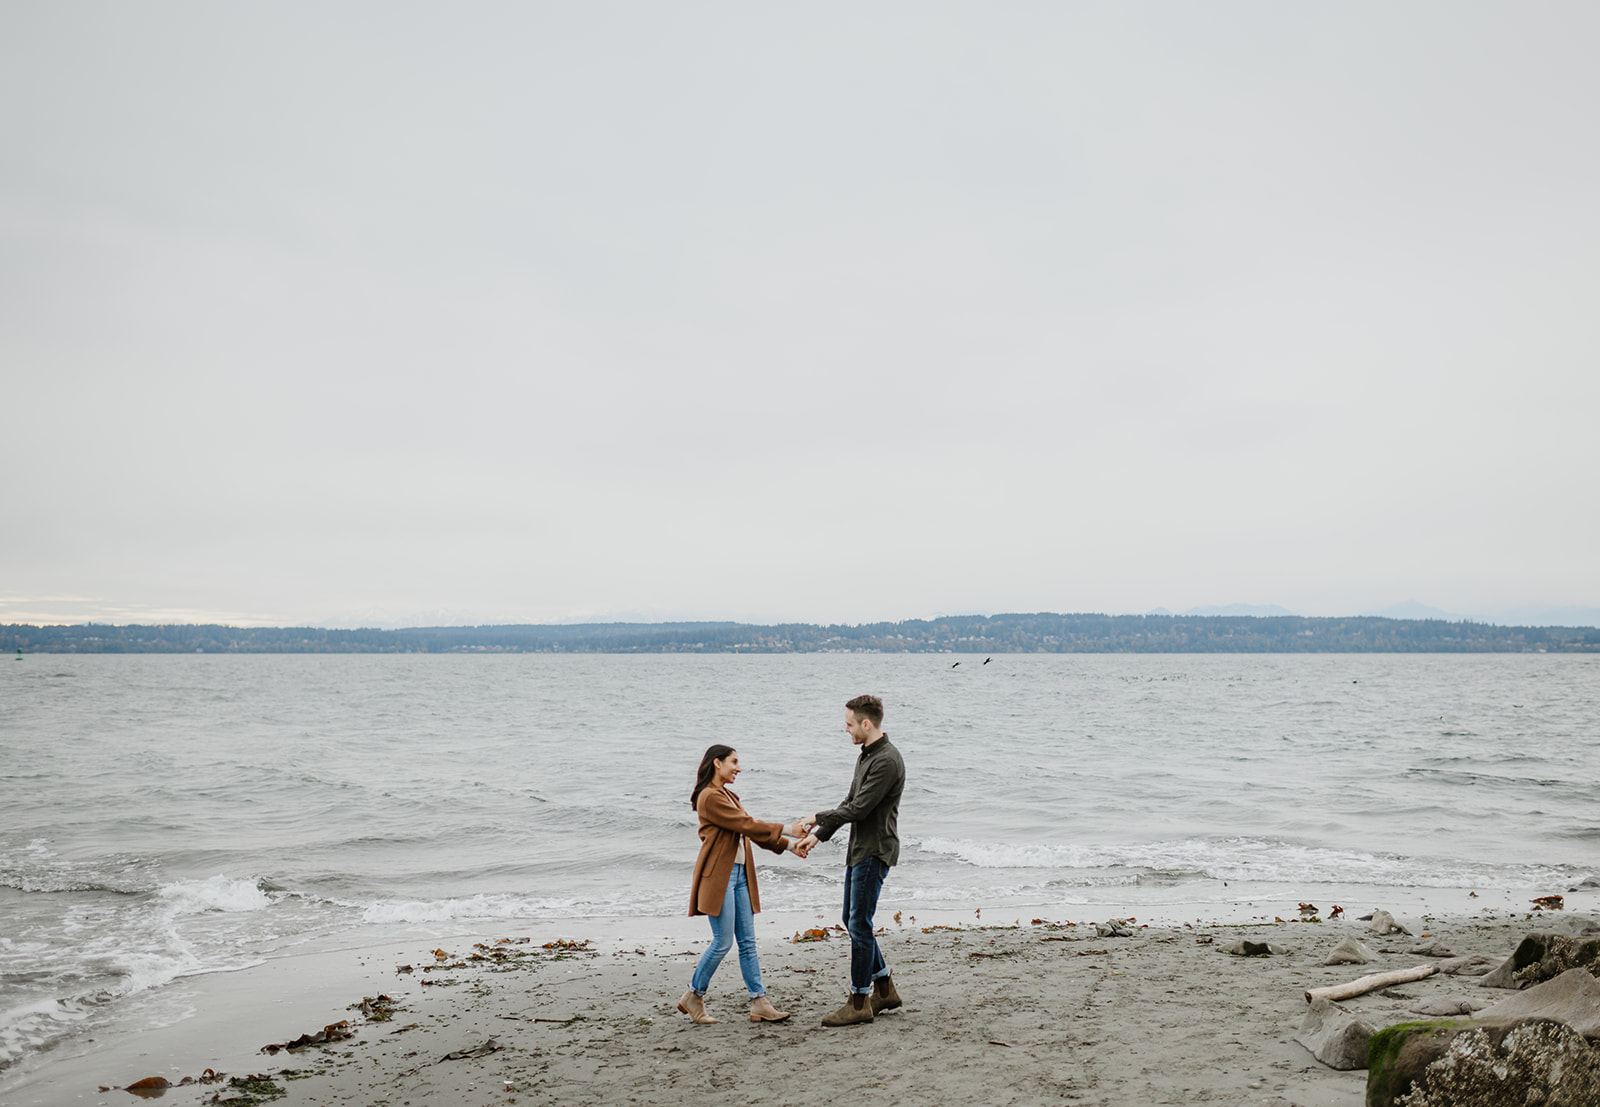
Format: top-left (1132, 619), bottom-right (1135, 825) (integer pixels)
top-left (797, 696), bottom-right (906, 1027)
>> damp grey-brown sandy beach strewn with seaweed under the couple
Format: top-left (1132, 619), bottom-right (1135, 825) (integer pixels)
top-left (10, 889), bottom-right (1597, 1107)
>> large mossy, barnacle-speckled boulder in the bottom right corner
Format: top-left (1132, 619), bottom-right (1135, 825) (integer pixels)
top-left (1366, 1019), bottom-right (1600, 1107)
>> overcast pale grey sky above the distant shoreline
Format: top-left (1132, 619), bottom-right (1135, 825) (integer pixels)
top-left (0, 0), bottom-right (1600, 624)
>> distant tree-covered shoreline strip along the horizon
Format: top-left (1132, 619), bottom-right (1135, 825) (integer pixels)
top-left (0, 613), bottom-right (1600, 653)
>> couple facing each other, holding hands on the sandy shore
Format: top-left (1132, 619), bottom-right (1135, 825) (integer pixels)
top-left (678, 696), bottom-right (906, 1027)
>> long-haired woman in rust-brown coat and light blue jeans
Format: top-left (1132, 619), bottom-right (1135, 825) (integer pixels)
top-left (678, 745), bottom-right (805, 1022)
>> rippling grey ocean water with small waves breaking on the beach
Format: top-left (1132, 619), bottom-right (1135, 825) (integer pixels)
top-left (0, 654), bottom-right (1600, 1086)
